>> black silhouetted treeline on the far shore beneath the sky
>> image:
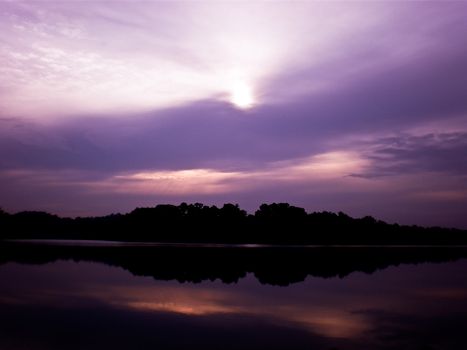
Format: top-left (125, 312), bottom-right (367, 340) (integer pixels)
top-left (0, 203), bottom-right (467, 245)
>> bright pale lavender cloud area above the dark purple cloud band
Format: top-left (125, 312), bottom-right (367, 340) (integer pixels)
top-left (0, 2), bottom-right (467, 120)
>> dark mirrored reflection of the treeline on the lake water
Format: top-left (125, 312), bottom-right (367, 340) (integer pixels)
top-left (0, 241), bottom-right (467, 286)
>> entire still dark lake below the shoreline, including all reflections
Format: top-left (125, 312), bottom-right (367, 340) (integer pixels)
top-left (0, 243), bottom-right (467, 350)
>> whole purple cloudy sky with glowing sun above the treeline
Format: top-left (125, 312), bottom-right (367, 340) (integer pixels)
top-left (0, 1), bottom-right (467, 228)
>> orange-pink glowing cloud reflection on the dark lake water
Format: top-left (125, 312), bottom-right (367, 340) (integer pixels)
top-left (85, 285), bottom-right (372, 338)
